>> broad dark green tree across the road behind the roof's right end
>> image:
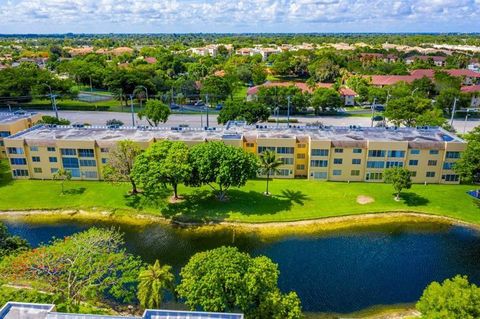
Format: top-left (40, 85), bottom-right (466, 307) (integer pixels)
top-left (385, 96), bottom-right (433, 126)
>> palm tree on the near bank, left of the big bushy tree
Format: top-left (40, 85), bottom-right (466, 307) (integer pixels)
top-left (137, 260), bottom-right (174, 308)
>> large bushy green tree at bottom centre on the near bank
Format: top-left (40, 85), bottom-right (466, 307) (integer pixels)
top-left (177, 247), bottom-right (302, 319)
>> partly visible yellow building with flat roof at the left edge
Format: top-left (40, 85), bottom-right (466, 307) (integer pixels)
top-left (0, 112), bottom-right (42, 159)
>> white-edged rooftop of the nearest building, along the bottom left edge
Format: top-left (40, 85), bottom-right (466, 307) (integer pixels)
top-left (0, 302), bottom-right (243, 319)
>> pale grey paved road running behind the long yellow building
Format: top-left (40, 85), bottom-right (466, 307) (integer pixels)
top-left (35, 111), bottom-right (480, 133)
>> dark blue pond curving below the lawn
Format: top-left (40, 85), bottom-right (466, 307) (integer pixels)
top-left (6, 220), bottom-right (480, 313)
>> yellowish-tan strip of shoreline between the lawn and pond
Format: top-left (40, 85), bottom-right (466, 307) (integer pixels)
top-left (0, 210), bottom-right (480, 234)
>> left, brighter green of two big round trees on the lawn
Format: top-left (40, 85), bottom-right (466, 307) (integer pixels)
top-left (132, 140), bottom-right (193, 199)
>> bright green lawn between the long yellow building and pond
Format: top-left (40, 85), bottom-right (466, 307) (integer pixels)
top-left (0, 161), bottom-right (480, 223)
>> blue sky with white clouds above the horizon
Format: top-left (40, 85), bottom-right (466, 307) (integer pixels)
top-left (0, 0), bottom-right (480, 33)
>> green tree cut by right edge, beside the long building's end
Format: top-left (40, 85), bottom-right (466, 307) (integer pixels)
top-left (454, 126), bottom-right (480, 183)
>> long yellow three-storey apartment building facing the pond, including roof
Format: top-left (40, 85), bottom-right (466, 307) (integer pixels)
top-left (5, 122), bottom-right (466, 183)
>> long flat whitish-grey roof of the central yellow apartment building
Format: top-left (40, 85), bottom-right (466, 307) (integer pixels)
top-left (6, 125), bottom-right (465, 143)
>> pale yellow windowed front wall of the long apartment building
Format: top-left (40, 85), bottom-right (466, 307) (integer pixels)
top-left (5, 131), bottom-right (466, 184)
